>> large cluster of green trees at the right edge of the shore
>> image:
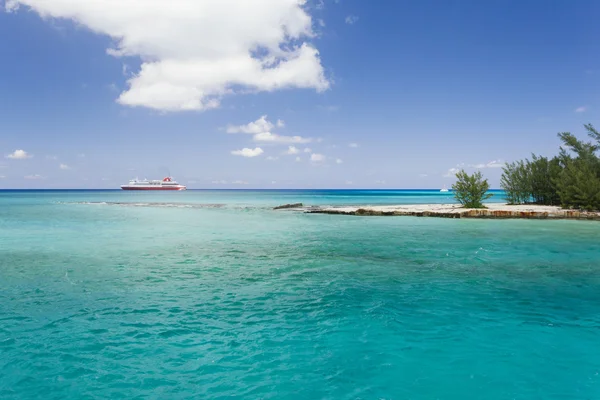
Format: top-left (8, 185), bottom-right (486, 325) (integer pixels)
top-left (502, 124), bottom-right (600, 211)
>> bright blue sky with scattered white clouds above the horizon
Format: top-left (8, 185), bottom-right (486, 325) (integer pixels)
top-left (0, 0), bottom-right (600, 189)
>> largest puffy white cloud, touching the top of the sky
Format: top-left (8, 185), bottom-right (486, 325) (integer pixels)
top-left (6, 0), bottom-right (329, 111)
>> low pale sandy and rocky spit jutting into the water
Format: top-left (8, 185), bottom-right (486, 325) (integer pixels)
top-left (289, 203), bottom-right (600, 221)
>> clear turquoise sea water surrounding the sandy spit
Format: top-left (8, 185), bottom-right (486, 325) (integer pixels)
top-left (0, 191), bottom-right (600, 399)
